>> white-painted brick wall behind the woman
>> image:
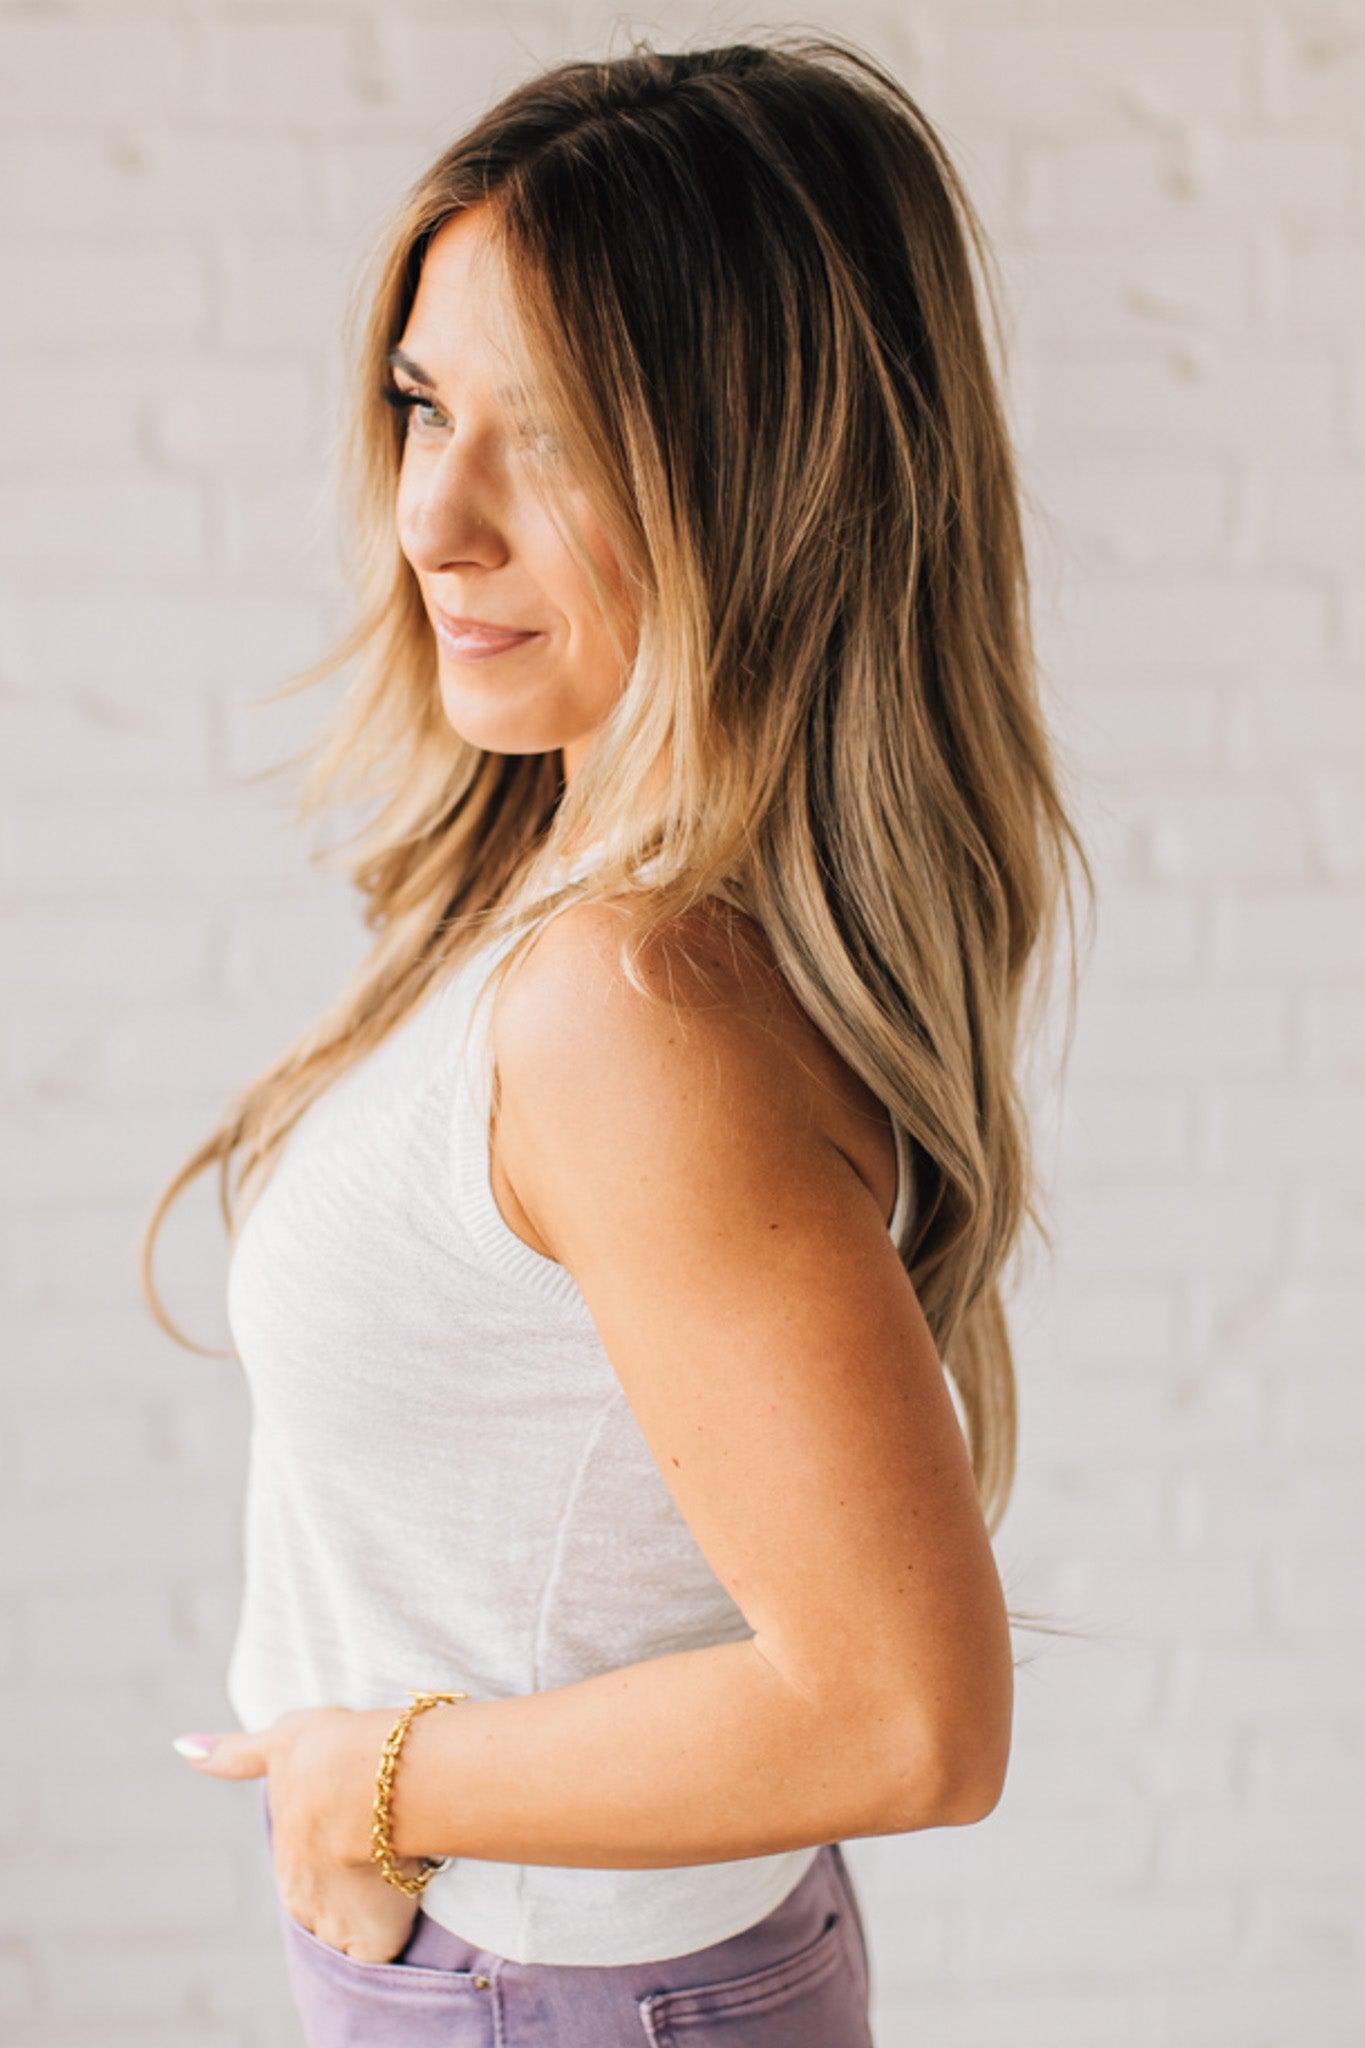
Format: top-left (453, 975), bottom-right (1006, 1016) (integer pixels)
top-left (0, 0), bottom-right (1365, 2048)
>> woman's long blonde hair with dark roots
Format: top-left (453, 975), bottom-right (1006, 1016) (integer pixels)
top-left (141, 35), bottom-right (1095, 1630)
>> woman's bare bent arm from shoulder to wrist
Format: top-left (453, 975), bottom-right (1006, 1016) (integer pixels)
top-left (327, 905), bottom-right (1013, 1868)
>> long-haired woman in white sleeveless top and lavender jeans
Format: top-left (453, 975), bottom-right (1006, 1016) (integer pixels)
top-left (143, 37), bottom-right (1089, 2048)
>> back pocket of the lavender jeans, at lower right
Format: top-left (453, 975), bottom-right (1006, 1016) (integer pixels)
top-left (636, 1907), bottom-right (866, 2048)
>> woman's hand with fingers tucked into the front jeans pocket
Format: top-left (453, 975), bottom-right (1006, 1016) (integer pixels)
top-left (176, 1706), bottom-right (420, 1962)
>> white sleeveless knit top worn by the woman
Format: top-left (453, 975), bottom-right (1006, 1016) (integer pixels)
top-left (227, 856), bottom-right (911, 1964)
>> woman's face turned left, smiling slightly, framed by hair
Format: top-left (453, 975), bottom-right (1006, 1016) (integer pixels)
top-left (391, 209), bottom-right (634, 776)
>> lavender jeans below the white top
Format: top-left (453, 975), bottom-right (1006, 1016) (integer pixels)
top-left (262, 1780), bottom-right (872, 2048)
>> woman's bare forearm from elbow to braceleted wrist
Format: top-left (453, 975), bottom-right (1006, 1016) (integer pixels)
top-left (336, 1640), bottom-right (952, 1870)
